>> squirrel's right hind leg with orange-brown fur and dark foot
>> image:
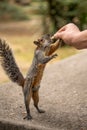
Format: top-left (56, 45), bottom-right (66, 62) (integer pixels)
top-left (32, 90), bottom-right (45, 113)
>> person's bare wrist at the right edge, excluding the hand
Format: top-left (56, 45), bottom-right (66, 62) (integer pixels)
top-left (72, 30), bottom-right (87, 49)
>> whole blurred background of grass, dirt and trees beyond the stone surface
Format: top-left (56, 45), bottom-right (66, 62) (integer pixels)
top-left (0, 0), bottom-right (87, 83)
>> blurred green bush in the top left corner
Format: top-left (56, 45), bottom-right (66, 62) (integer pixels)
top-left (0, 1), bottom-right (29, 21)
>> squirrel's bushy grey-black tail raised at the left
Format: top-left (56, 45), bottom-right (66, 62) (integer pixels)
top-left (0, 39), bottom-right (24, 86)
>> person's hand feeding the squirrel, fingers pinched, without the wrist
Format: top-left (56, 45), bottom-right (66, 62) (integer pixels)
top-left (54, 23), bottom-right (80, 46)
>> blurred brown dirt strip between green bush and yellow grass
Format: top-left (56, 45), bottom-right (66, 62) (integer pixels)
top-left (0, 18), bottom-right (43, 36)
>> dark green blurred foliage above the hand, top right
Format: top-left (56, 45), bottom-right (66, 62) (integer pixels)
top-left (41, 0), bottom-right (87, 32)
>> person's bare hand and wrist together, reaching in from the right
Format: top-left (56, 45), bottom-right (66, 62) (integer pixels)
top-left (54, 23), bottom-right (87, 49)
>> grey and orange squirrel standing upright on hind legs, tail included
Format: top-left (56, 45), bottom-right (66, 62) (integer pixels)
top-left (0, 34), bottom-right (60, 120)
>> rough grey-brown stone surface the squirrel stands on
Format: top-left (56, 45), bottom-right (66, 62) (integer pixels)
top-left (0, 51), bottom-right (87, 130)
